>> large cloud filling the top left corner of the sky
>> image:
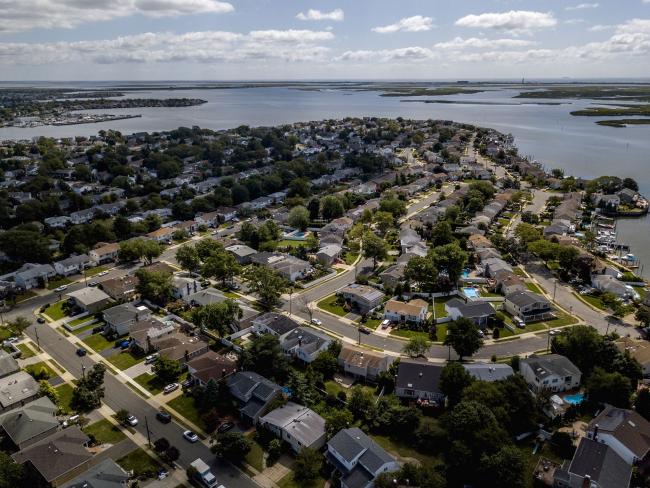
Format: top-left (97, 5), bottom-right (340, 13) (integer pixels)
top-left (0, 0), bottom-right (234, 34)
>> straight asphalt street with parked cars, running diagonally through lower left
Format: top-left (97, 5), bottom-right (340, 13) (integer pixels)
top-left (26, 324), bottom-right (259, 488)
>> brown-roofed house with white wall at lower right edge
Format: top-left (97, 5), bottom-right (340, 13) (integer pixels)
top-left (587, 405), bottom-right (650, 466)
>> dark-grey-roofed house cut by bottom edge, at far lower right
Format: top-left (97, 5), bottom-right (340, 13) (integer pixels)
top-left (553, 437), bottom-right (632, 488)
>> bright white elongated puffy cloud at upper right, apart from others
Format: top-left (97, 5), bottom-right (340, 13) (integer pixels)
top-left (456, 10), bottom-right (557, 35)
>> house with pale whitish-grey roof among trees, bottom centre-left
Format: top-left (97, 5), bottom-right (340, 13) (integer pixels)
top-left (259, 402), bottom-right (326, 453)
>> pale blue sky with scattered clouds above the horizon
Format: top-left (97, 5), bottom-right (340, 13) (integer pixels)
top-left (0, 0), bottom-right (650, 81)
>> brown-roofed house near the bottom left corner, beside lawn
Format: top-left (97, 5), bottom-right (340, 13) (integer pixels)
top-left (11, 426), bottom-right (93, 487)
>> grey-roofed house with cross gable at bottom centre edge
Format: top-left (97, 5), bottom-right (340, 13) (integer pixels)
top-left (326, 427), bottom-right (399, 488)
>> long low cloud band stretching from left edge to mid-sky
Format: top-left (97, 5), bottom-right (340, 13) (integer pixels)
top-left (0, 30), bottom-right (334, 65)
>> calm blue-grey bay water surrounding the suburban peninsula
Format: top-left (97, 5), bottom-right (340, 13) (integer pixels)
top-left (0, 84), bottom-right (650, 277)
